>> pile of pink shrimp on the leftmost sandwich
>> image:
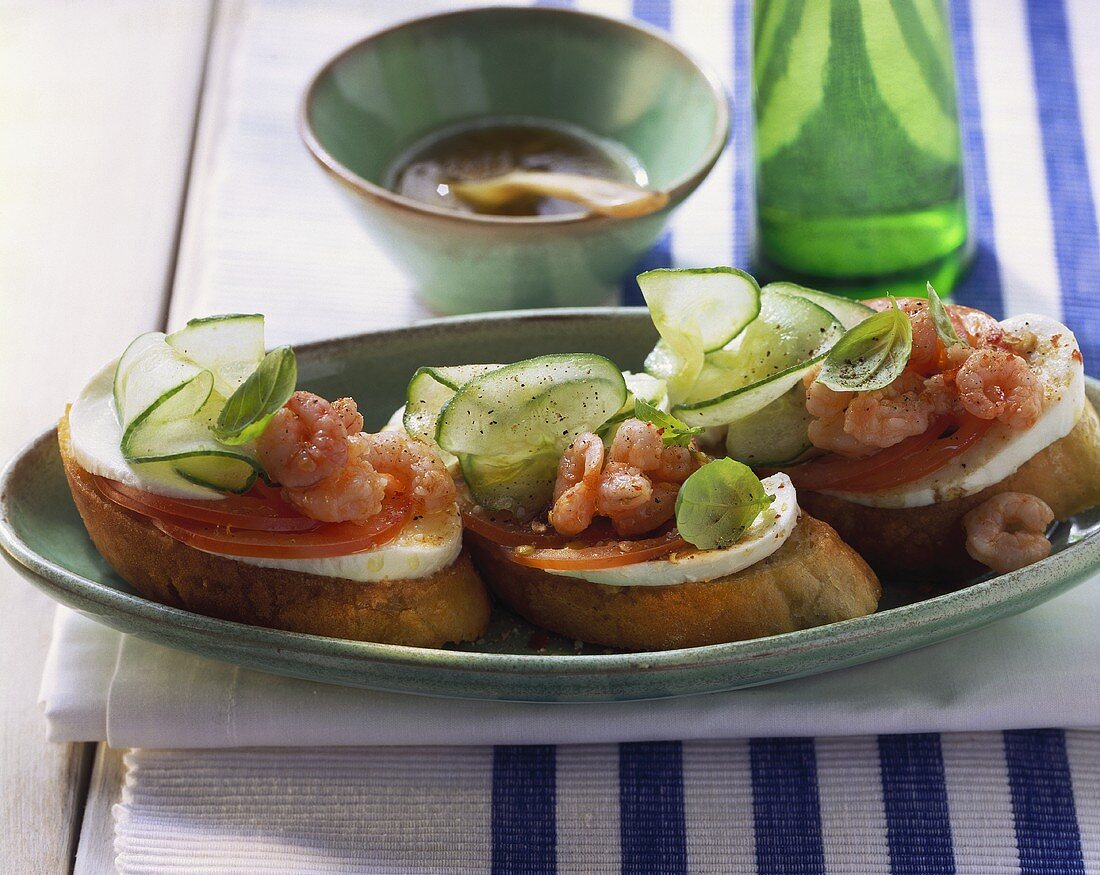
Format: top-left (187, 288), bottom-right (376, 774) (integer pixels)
top-left (256, 392), bottom-right (455, 523)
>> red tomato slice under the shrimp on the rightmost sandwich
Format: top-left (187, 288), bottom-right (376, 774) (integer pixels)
top-left (787, 414), bottom-right (992, 492)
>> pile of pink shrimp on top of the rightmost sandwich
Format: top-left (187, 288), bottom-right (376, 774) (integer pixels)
top-left (805, 299), bottom-right (1043, 458)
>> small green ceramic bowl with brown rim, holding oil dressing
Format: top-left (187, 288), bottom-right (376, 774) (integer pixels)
top-left (300, 8), bottom-right (729, 313)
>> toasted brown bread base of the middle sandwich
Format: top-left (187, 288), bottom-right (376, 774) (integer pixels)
top-left (465, 513), bottom-right (880, 650)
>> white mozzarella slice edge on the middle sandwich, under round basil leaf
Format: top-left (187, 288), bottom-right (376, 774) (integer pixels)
top-left (549, 474), bottom-right (799, 587)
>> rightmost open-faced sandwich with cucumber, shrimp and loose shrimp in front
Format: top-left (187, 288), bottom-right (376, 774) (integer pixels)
top-left (639, 269), bottom-right (1100, 581)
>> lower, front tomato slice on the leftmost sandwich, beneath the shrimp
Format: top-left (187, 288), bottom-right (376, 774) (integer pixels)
top-left (153, 501), bottom-right (411, 559)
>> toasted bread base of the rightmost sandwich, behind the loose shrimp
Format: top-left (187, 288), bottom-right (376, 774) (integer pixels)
top-left (799, 402), bottom-right (1100, 582)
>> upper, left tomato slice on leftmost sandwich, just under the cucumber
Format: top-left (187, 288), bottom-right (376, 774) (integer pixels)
top-left (95, 477), bottom-right (321, 532)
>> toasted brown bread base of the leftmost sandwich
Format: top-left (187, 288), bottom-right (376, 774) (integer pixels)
top-left (57, 415), bottom-right (490, 647)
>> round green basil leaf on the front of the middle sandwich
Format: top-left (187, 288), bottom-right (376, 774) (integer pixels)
top-left (677, 459), bottom-right (776, 550)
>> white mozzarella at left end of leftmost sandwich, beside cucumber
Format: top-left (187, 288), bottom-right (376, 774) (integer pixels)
top-left (69, 360), bottom-right (224, 501)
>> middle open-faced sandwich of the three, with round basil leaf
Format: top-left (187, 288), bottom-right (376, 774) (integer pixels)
top-left (403, 353), bottom-right (879, 649)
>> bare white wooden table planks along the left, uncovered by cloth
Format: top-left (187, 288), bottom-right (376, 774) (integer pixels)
top-left (0, 0), bottom-right (216, 874)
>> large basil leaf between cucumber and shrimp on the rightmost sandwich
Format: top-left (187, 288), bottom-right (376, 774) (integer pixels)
top-left (817, 300), bottom-right (913, 392)
